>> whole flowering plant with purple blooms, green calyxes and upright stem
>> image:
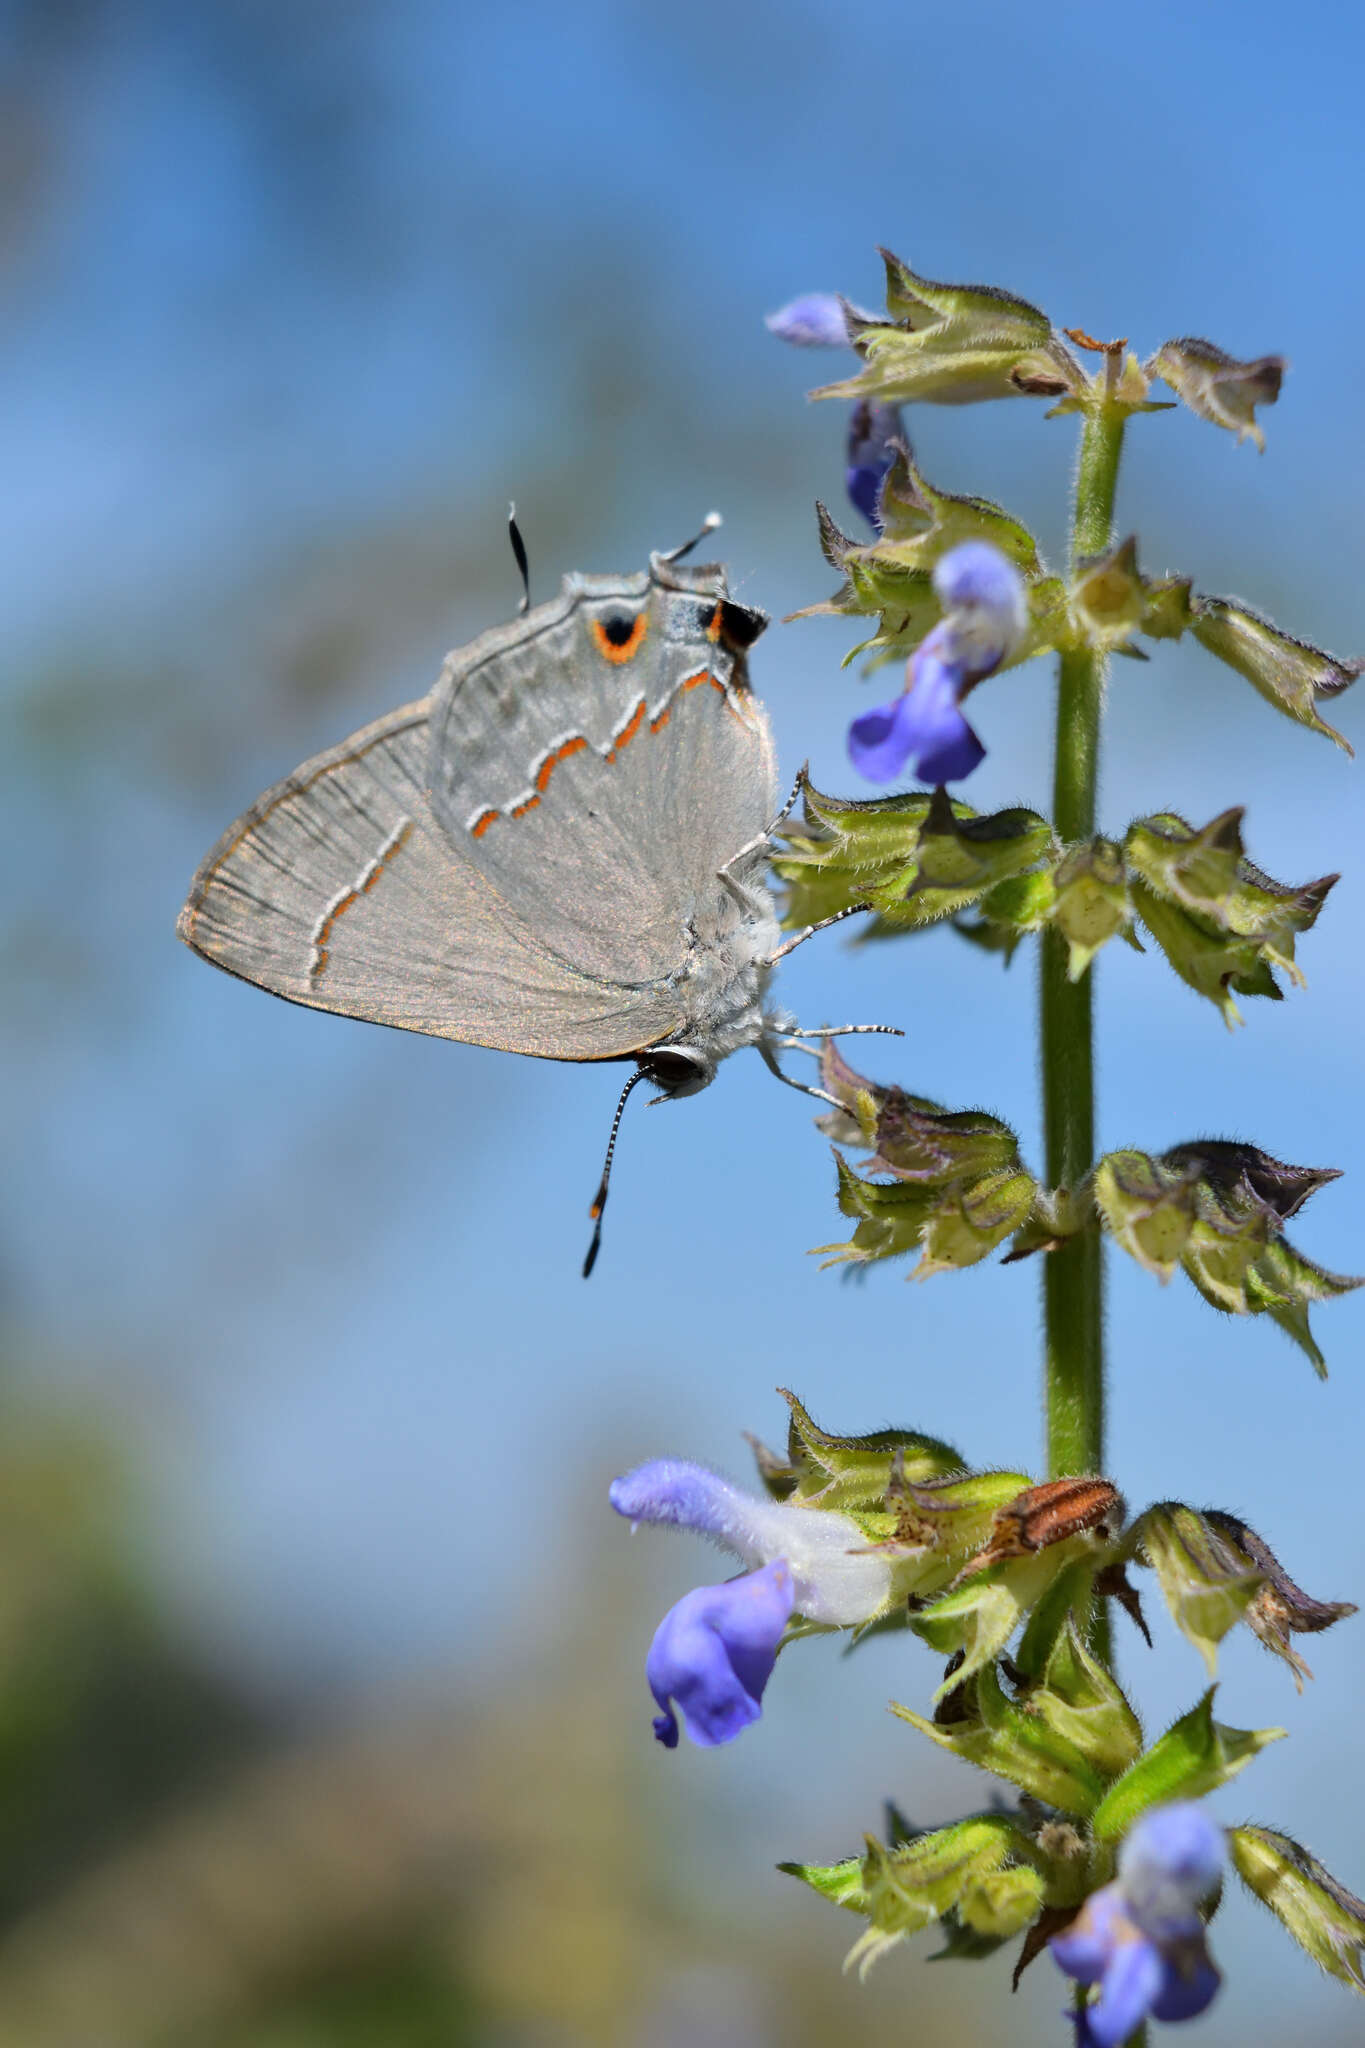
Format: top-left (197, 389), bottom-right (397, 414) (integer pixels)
top-left (612, 252), bottom-right (1365, 2048)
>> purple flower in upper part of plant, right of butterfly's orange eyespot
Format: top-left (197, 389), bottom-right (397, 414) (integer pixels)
top-left (849, 541), bottom-right (1029, 782)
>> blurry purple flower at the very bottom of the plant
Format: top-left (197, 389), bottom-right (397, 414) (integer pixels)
top-left (1050, 1802), bottom-right (1224, 2048)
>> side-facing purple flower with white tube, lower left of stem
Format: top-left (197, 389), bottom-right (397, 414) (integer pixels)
top-left (610, 1458), bottom-right (892, 1749)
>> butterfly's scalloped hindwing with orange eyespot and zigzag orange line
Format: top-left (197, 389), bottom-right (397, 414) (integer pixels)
top-left (428, 557), bottom-right (776, 989)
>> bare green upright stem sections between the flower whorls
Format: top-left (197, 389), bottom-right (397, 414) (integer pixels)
top-left (1040, 399), bottom-right (1126, 1479)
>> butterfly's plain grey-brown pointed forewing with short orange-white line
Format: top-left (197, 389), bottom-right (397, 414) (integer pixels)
top-left (178, 698), bottom-right (681, 1059)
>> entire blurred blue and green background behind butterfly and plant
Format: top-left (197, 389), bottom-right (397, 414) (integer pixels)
top-left (0, 0), bottom-right (1365, 2048)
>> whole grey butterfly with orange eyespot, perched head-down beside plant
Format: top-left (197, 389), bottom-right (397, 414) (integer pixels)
top-left (178, 514), bottom-right (892, 1272)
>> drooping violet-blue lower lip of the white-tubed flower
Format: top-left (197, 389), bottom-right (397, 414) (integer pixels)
top-left (645, 1559), bottom-right (796, 1749)
